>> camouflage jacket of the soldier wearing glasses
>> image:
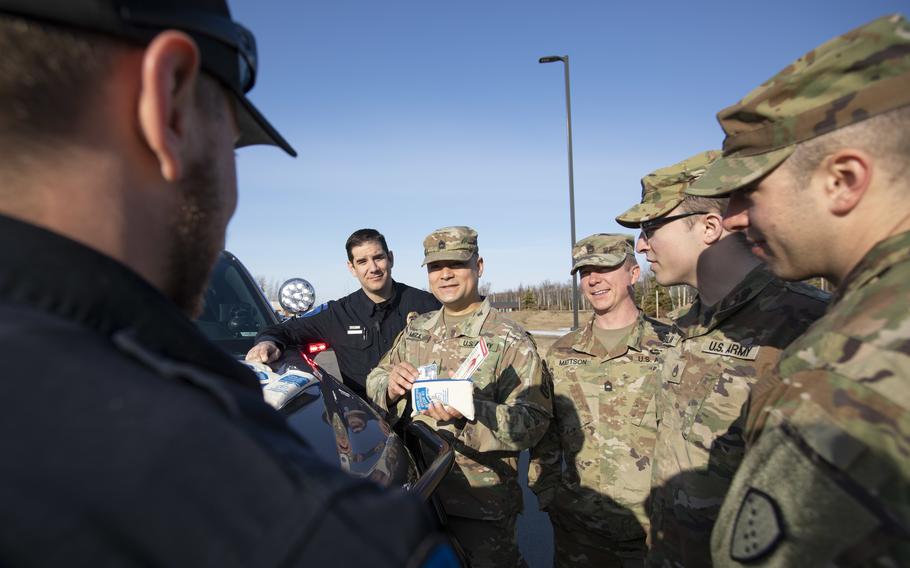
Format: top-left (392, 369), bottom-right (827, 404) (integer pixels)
top-left (649, 266), bottom-right (827, 566)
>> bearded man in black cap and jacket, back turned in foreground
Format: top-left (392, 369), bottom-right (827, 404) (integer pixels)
top-left (0, 0), bottom-right (456, 566)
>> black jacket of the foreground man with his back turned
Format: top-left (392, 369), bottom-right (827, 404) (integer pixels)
top-left (0, 217), bottom-right (452, 566)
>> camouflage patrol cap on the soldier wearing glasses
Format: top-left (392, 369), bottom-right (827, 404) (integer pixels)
top-left (616, 150), bottom-right (721, 228)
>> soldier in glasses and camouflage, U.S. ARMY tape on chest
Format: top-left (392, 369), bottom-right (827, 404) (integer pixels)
top-left (617, 151), bottom-right (826, 566)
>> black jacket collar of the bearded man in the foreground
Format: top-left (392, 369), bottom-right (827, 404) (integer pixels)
top-left (0, 215), bottom-right (259, 389)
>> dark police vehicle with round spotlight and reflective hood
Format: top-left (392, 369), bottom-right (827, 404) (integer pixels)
top-left (196, 251), bottom-right (455, 502)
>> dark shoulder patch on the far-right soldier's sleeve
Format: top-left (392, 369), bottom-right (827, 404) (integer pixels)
top-left (730, 488), bottom-right (784, 562)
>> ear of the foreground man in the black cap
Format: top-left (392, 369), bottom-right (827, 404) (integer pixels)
top-left (138, 30), bottom-right (199, 182)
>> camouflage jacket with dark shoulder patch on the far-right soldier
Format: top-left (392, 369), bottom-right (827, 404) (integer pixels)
top-left (712, 232), bottom-right (910, 566)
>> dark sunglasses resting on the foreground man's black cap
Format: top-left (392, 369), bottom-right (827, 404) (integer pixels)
top-left (121, 7), bottom-right (258, 93)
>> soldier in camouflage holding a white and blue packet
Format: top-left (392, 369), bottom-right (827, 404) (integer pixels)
top-left (367, 227), bottom-right (552, 567)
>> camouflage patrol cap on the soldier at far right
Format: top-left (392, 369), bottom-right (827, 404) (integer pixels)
top-left (686, 14), bottom-right (910, 196)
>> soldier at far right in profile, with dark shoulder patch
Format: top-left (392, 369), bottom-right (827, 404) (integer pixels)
top-left (690, 16), bottom-right (910, 566)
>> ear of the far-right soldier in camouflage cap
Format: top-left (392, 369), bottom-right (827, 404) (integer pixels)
top-left (810, 148), bottom-right (873, 216)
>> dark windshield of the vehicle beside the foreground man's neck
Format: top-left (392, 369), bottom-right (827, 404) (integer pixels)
top-left (196, 253), bottom-right (276, 358)
